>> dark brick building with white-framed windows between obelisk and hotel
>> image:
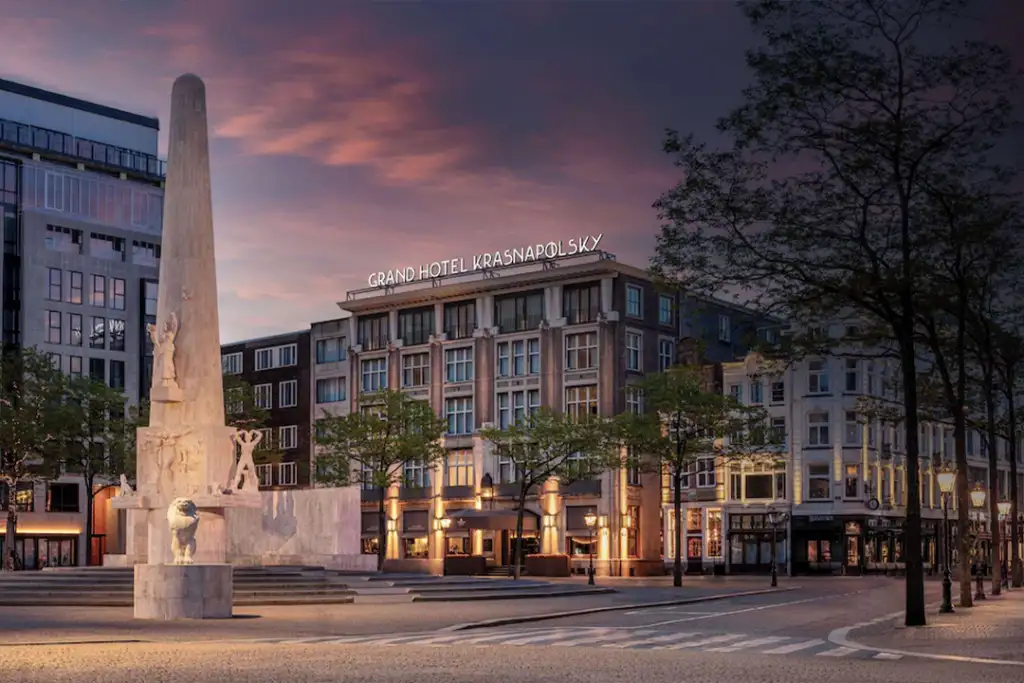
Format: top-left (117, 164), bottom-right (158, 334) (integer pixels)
top-left (220, 330), bottom-right (311, 489)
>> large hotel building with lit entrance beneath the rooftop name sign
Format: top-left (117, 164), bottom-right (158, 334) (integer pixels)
top-left (327, 252), bottom-right (770, 575)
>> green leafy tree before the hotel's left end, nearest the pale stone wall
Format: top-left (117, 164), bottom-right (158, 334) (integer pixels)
top-left (314, 390), bottom-right (447, 570)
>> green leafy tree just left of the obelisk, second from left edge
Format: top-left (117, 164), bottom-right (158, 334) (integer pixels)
top-left (55, 377), bottom-right (135, 559)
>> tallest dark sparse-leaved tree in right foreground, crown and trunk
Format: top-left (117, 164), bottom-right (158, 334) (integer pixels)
top-left (653, 0), bottom-right (1016, 626)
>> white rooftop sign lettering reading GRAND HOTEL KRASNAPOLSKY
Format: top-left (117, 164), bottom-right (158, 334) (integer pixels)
top-left (368, 232), bottom-right (604, 287)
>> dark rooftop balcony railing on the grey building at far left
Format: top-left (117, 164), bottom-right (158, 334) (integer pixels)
top-left (0, 119), bottom-right (167, 178)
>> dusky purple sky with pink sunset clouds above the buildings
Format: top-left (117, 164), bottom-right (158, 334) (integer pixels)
top-left (0, 0), bottom-right (1024, 341)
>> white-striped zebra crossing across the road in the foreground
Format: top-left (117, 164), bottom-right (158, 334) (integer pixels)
top-left (258, 627), bottom-right (902, 660)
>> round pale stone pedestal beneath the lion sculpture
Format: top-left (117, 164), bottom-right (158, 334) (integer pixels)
top-left (135, 564), bottom-right (234, 622)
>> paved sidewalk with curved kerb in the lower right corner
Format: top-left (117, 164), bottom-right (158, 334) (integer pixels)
top-left (849, 587), bottom-right (1024, 663)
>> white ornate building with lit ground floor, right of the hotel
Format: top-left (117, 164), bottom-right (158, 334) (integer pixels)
top-left (670, 335), bottom-right (1024, 574)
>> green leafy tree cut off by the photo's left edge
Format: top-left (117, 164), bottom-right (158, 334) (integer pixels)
top-left (0, 348), bottom-right (67, 569)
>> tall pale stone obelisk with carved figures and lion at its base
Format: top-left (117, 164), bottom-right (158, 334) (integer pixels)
top-left (113, 75), bottom-right (261, 618)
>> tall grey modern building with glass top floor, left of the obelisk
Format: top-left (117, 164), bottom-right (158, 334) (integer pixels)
top-left (0, 80), bottom-right (164, 568)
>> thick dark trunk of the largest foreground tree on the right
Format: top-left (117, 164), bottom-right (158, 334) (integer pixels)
top-left (900, 325), bottom-right (926, 626)
